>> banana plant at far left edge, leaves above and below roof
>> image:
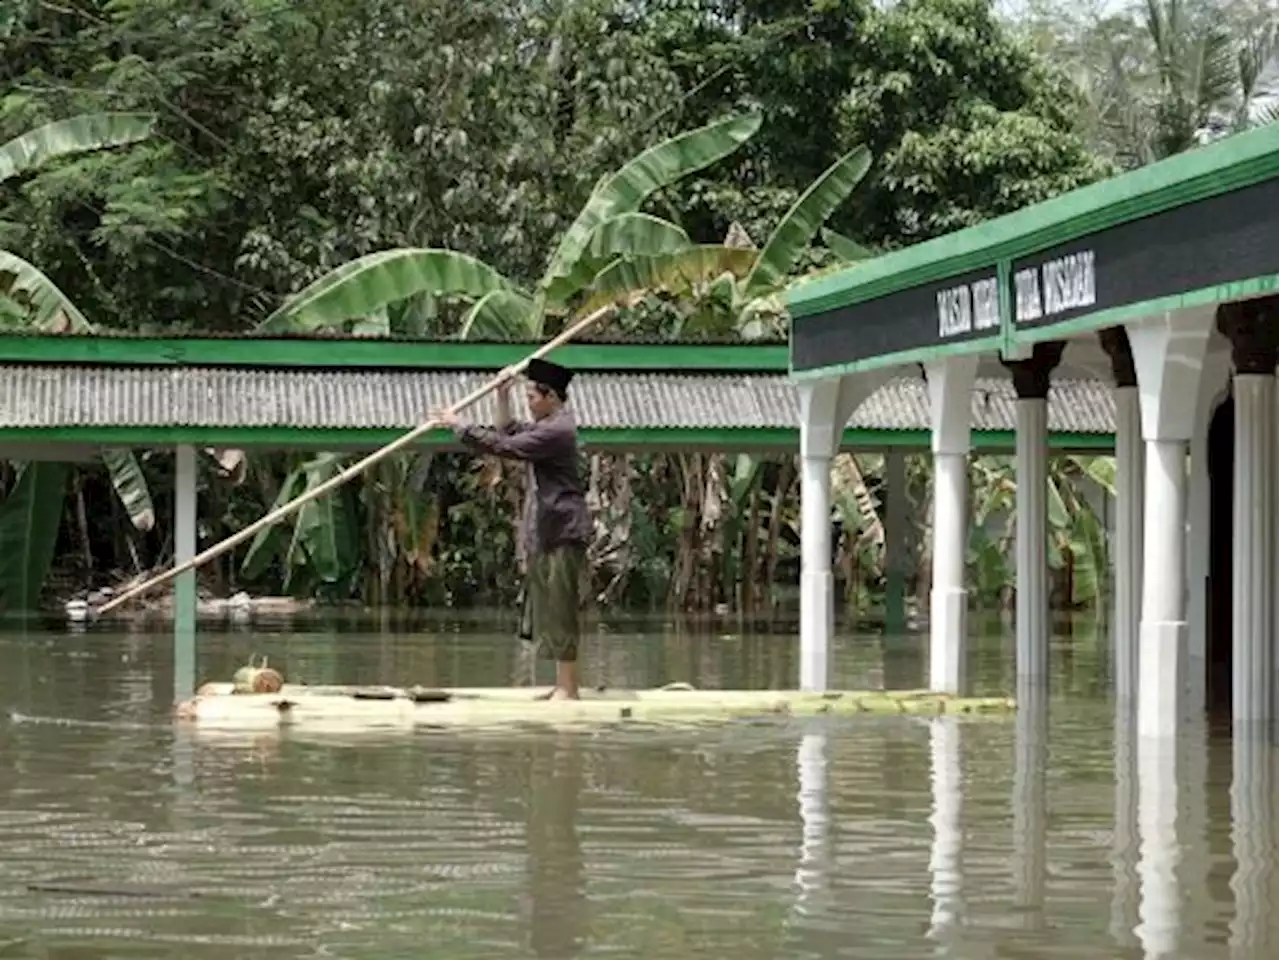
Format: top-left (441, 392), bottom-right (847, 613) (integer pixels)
top-left (0, 113), bottom-right (155, 611)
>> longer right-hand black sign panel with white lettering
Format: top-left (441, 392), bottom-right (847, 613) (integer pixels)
top-left (1008, 179), bottom-right (1280, 328)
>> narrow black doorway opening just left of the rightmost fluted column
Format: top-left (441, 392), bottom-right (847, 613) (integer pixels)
top-left (1190, 396), bottom-right (1235, 714)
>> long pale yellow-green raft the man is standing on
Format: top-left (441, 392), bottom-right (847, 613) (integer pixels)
top-left (175, 684), bottom-right (1016, 732)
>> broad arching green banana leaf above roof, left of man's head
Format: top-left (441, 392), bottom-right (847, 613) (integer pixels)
top-left (259, 247), bottom-right (520, 332)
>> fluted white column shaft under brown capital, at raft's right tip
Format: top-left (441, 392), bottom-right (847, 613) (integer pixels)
top-left (1014, 398), bottom-right (1048, 680)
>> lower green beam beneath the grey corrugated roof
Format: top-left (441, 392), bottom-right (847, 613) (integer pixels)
top-left (0, 426), bottom-right (1115, 451)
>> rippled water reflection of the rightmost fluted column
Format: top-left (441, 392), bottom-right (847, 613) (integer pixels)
top-left (1229, 730), bottom-right (1280, 960)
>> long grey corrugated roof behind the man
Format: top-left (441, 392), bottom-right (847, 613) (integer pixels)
top-left (0, 365), bottom-right (1115, 434)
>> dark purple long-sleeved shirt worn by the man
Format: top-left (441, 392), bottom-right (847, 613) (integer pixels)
top-left (453, 407), bottom-right (591, 556)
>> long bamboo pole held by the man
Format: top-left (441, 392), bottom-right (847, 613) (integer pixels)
top-left (93, 303), bottom-right (616, 617)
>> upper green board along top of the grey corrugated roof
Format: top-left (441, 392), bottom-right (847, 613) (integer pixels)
top-left (0, 334), bottom-right (790, 374)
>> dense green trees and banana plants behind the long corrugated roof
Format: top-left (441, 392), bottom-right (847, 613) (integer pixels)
top-left (0, 0), bottom-right (1131, 616)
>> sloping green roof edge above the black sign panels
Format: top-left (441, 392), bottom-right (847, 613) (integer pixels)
top-left (783, 124), bottom-right (1280, 320)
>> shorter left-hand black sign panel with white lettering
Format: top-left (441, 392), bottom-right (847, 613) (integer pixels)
top-left (791, 264), bottom-right (1000, 370)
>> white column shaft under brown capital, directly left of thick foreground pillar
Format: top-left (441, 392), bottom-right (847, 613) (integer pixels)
top-left (1111, 387), bottom-right (1147, 700)
